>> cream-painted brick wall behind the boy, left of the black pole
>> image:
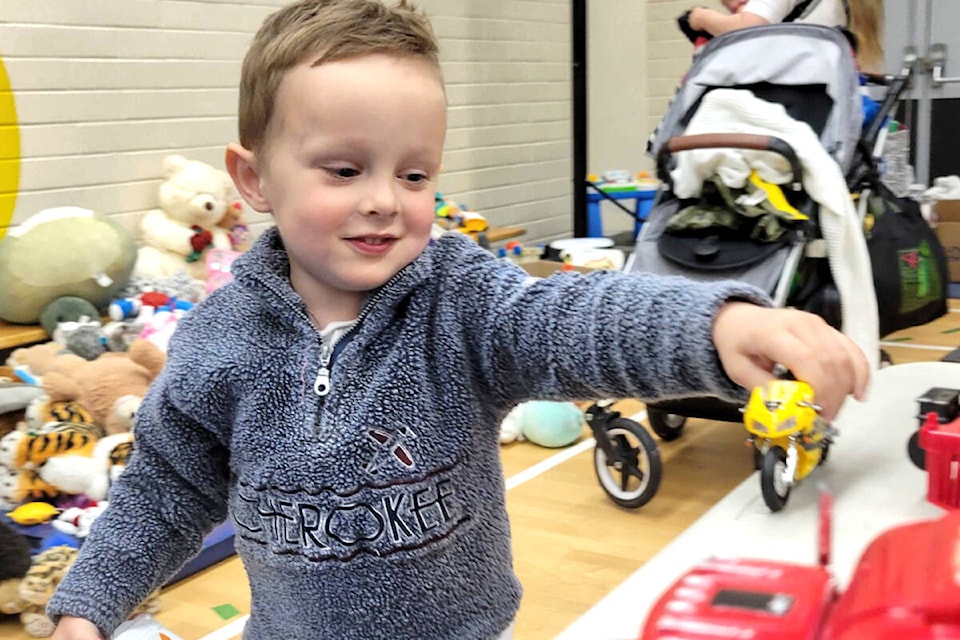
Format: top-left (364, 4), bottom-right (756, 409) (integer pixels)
top-left (0, 0), bottom-right (572, 248)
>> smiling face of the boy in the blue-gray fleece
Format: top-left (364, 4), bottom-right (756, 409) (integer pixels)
top-left (251, 55), bottom-right (446, 312)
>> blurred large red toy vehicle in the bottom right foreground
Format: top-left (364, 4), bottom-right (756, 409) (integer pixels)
top-left (639, 494), bottom-right (960, 640)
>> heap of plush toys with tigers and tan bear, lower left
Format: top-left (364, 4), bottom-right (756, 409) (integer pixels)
top-left (0, 339), bottom-right (166, 638)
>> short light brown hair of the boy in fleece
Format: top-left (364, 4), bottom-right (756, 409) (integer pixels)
top-left (238, 0), bottom-right (440, 152)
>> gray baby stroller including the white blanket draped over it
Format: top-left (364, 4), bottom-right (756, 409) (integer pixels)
top-left (596, 23), bottom-right (946, 504)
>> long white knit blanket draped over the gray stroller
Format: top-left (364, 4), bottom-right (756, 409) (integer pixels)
top-left (671, 89), bottom-right (880, 369)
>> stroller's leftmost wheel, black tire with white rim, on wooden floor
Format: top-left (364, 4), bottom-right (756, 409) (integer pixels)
top-left (593, 418), bottom-right (663, 509)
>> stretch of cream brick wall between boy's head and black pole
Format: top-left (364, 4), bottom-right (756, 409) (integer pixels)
top-left (421, 0), bottom-right (573, 242)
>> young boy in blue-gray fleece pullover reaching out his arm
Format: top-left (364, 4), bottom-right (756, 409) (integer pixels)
top-left (48, 0), bottom-right (869, 640)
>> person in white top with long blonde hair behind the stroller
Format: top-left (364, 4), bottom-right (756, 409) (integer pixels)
top-left (689, 0), bottom-right (883, 73)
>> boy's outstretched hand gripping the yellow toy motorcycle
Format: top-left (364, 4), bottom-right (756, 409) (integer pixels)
top-left (713, 302), bottom-right (870, 422)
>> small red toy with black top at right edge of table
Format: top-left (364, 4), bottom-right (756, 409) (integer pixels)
top-left (907, 387), bottom-right (960, 509)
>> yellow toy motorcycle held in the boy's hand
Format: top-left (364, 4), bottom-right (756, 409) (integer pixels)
top-left (743, 376), bottom-right (837, 512)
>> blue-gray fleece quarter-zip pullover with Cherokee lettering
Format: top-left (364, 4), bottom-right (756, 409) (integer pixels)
top-left (48, 230), bottom-right (766, 640)
